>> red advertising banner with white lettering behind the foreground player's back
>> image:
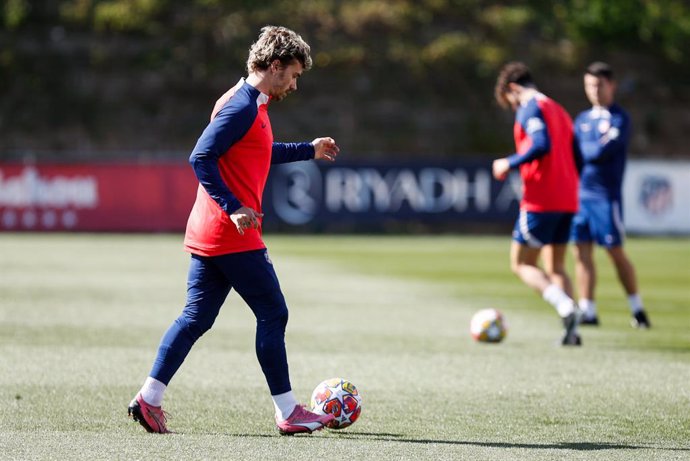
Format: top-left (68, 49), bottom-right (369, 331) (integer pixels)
top-left (0, 163), bottom-right (198, 231)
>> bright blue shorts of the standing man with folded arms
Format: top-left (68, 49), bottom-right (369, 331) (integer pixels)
top-left (570, 200), bottom-right (625, 248)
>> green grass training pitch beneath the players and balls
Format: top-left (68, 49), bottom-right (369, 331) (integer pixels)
top-left (0, 234), bottom-right (690, 461)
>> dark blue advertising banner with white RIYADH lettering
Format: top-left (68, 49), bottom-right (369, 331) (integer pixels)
top-left (263, 161), bottom-right (521, 231)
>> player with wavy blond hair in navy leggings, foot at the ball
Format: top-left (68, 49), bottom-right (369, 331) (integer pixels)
top-left (129, 26), bottom-right (339, 434)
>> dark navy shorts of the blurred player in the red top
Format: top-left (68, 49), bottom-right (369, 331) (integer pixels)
top-left (513, 210), bottom-right (574, 248)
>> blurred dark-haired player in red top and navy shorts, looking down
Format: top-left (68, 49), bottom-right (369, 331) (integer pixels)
top-left (492, 62), bottom-right (582, 346)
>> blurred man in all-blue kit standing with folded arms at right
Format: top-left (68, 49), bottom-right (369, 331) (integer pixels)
top-left (571, 62), bottom-right (651, 328)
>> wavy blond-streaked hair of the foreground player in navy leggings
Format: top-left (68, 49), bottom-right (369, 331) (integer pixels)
top-left (247, 26), bottom-right (312, 73)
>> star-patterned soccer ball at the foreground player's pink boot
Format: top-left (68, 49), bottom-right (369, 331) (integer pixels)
top-left (311, 378), bottom-right (362, 429)
